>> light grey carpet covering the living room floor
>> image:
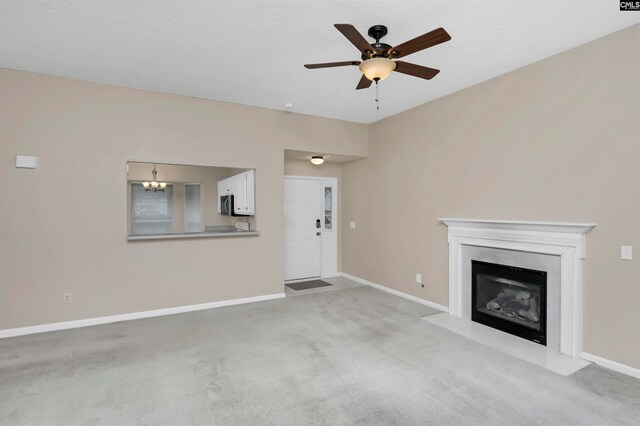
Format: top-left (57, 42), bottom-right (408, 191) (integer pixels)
top-left (0, 286), bottom-right (640, 425)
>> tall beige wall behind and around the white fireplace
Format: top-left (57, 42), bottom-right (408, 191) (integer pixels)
top-left (342, 26), bottom-right (640, 368)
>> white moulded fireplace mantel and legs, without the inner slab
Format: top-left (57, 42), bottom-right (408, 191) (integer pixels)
top-left (439, 218), bottom-right (596, 358)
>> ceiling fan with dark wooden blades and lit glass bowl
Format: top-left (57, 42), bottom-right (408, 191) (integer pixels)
top-left (305, 24), bottom-right (451, 90)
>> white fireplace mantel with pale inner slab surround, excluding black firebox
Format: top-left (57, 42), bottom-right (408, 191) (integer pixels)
top-left (440, 218), bottom-right (596, 358)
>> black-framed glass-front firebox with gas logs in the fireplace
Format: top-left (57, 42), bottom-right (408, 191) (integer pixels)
top-left (471, 260), bottom-right (547, 346)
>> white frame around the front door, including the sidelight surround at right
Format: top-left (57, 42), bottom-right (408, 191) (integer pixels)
top-left (283, 175), bottom-right (340, 282)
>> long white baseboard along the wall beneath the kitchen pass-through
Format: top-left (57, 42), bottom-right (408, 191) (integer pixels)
top-left (0, 293), bottom-right (285, 339)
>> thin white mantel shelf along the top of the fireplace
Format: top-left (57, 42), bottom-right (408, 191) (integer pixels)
top-left (438, 217), bottom-right (596, 234)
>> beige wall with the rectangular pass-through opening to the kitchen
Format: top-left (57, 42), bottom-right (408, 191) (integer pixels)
top-left (0, 70), bottom-right (368, 329)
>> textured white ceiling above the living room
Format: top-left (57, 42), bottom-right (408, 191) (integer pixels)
top-left (0, 0), bottom-right (640, 123)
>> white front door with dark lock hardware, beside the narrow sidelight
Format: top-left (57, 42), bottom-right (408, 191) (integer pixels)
top-left (284, 177), bottom-right (324, 281)
